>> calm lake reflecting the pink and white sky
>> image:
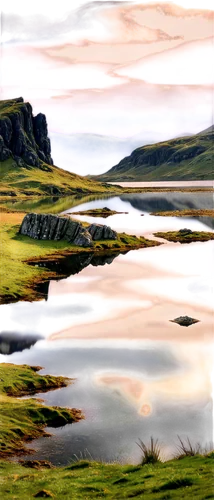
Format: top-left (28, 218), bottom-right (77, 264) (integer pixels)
top-left (7, 195), bottom-right (214, 464)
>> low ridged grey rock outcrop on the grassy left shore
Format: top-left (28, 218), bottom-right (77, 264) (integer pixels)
top-left (19, 213), bottom-right (118, 247)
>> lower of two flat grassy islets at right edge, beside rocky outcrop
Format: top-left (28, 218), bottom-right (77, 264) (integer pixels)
top-left (154, 228), bottom-right (214, 243)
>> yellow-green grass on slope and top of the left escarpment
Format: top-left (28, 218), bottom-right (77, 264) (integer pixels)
top-left (0, 95), bottom-right (120, 196)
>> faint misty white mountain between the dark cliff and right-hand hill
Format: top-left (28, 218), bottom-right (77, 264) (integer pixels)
top-left (49, 133), bottom-right (153, 175)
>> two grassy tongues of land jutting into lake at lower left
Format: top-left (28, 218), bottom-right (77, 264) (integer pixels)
top-left (0, 361), bottom-right (84, 458)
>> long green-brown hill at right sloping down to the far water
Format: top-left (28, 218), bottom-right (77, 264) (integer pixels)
top-left (90, 125), bottom-right (214, 182)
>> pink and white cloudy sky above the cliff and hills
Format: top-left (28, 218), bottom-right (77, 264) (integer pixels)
top-left (0, 0), bottom-right (214, 138)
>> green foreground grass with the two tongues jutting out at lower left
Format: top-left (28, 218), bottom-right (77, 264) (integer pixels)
top-left (0, 354), bottom-right (214, 500)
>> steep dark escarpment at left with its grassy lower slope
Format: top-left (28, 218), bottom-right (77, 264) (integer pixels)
top-left (0, 97), bottom-right (120, 196)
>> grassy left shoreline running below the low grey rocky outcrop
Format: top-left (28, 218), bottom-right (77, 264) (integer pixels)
top-left (0, 212), bottom-right (163, 306)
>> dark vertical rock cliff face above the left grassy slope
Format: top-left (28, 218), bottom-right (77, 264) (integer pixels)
top-left (0, 97), bottom-right (53, 167)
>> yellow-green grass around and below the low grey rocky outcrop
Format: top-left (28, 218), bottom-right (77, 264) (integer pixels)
top-left (0, 212), bottom-right (160, 303)
